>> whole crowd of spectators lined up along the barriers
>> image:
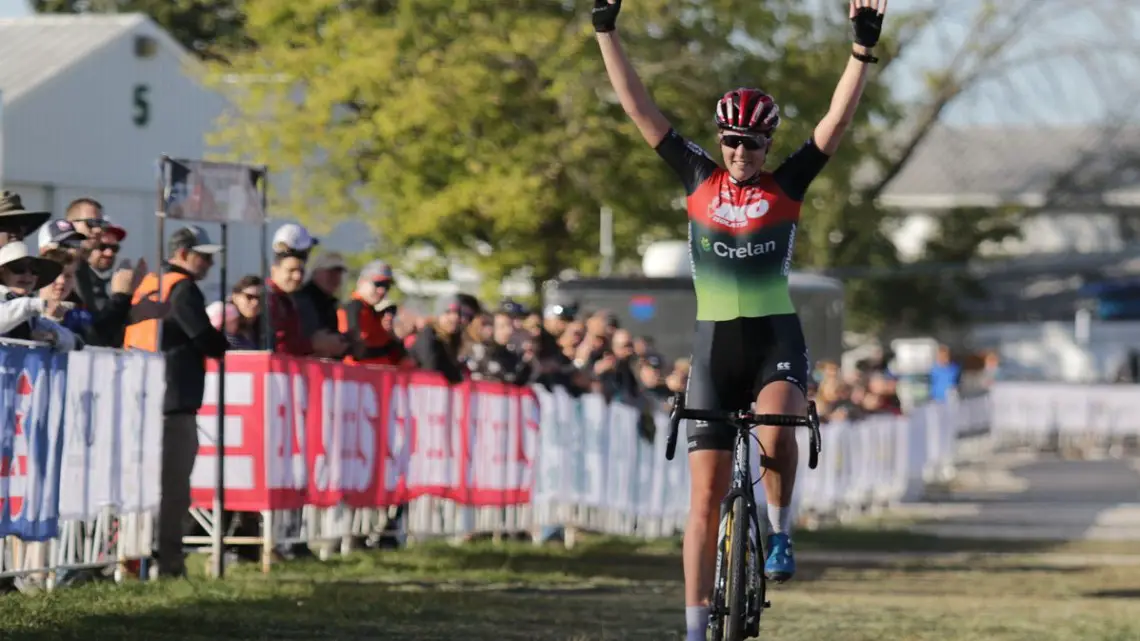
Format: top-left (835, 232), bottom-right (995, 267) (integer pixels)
top-left (0, 187), bottom-right (989, 565)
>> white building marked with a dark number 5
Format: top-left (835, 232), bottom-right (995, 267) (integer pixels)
top-left (0, 14), bottom-right (369, 297)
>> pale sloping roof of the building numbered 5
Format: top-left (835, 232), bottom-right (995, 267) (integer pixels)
top-left (0, 14), bottom-right (190, 105)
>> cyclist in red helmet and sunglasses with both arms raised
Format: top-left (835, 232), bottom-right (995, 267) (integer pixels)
top-left (592, 0), bottom-right (887, 640)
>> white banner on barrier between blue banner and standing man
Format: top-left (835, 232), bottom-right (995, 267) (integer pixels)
top-left (59, 348), bottom-right (165, 520)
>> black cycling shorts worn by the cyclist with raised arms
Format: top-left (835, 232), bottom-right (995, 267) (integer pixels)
top-left (685, 314), bottom-right (812, 452)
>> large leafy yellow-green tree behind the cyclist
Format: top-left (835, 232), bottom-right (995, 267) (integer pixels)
top-left (209, 0), bottom-right (897, 294)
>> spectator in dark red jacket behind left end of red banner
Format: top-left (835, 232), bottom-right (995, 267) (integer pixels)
top-left (268, 248), bottom-right (348, 358)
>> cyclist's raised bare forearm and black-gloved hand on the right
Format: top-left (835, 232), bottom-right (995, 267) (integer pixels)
top-left (814, 0), bottom-right (887, 156)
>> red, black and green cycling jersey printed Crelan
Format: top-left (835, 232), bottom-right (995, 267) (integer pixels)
top-left (657, 130), bottom-right (828, 321)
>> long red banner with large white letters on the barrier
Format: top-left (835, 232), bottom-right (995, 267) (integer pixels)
top-left (192, 352), bottom-right (539, 511)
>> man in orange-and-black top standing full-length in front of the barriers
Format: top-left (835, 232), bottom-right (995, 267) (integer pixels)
top-left (123, 226), bottom-right (227, 576)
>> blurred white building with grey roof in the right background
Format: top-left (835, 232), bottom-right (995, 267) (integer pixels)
top-left (880, 127), bottom-right (1140, 380)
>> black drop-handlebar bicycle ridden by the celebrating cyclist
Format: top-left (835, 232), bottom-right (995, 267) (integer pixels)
top-left (665, 392), bottom-right (823, 641)
